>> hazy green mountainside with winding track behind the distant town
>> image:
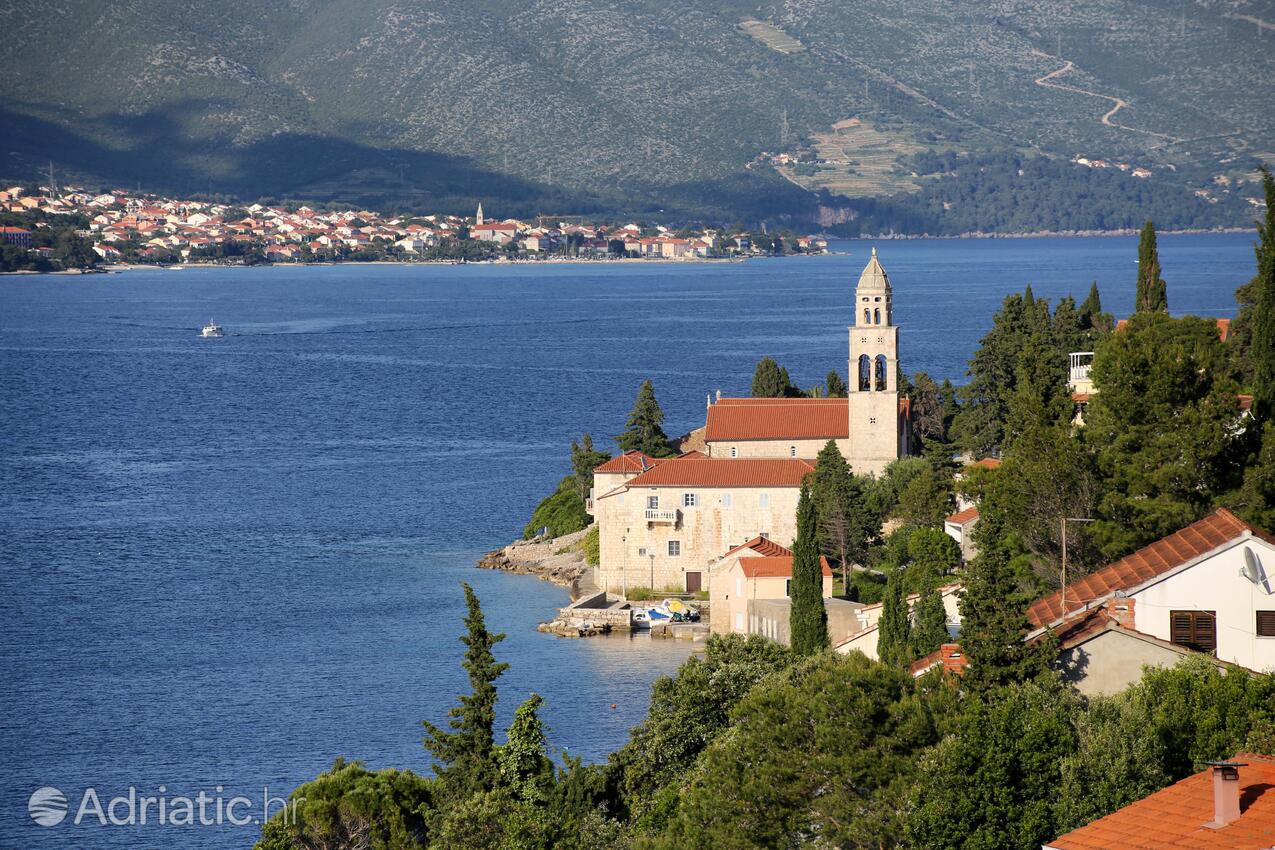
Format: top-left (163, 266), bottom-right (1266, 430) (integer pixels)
top-left (0, 0), bottom-right (1275, 232)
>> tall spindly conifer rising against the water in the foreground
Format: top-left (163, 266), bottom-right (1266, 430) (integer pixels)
top-left (422, 584), bottom-right (509, 798)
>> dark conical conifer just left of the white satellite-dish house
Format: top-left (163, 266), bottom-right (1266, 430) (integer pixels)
top-left (960, 547), bottom-right (1044, 688)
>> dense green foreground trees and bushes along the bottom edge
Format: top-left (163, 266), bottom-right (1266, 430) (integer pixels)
top-left (258, 598), bottom-right (1275, 850)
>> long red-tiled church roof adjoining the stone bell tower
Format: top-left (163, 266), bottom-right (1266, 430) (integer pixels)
top-left (704, 399), bottom-right (850, 442)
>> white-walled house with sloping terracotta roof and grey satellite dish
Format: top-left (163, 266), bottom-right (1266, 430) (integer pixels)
top-left (1026, 508), bottom-right (1275, 675)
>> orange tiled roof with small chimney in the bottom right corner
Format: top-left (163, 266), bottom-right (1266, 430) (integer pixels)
top-left (1044, 753), bottom-right (1275, 850)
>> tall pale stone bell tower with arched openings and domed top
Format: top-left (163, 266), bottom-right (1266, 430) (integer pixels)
top-left (845, 249), bottom-right (907, 475)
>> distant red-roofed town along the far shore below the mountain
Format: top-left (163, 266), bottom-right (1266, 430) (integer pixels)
top-left (0, 186), bottom-right (827, 271)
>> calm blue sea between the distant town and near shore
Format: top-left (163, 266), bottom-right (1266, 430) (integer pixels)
top-left (0, 234), bottom-right (1253, 849)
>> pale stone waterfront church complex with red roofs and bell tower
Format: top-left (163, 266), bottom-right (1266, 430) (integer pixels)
top-left (589, 249), bottom-right (912, 594)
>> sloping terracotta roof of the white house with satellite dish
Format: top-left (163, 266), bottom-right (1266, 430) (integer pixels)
top-left (1028, 507), bottom-right (1275, 627)
